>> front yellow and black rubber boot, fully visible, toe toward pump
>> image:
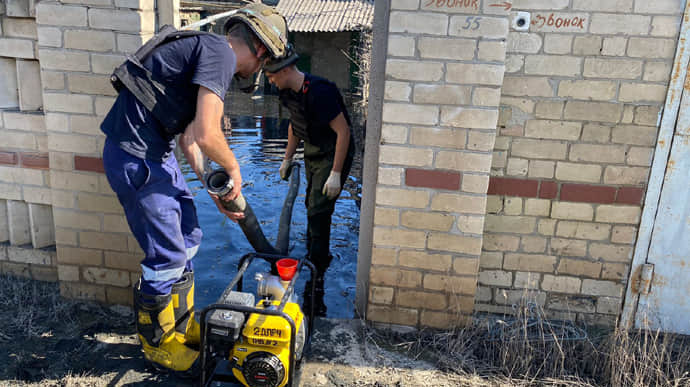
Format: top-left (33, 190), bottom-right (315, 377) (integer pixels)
top-left (134, 288), bottom-right (199, 371)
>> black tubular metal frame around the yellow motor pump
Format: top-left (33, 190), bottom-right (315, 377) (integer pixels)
top-left (199, 253), bottom-right (316, 387)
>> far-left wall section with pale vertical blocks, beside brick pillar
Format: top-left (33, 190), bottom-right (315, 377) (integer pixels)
top-left (0, 0), bottom-right (57, 281)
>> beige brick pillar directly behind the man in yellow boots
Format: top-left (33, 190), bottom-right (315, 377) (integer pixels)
top-left (36, 0), bottom-right (155, 304)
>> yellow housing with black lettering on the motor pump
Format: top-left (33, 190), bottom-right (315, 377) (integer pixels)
top-left (232, 300), bottom-right (306, 387)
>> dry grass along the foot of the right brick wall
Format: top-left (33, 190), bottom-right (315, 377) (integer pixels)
top-left (369, 304), bottom-right (690, 387)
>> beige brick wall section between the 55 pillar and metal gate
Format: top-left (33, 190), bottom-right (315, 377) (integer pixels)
top-left (475, 0), bottom-right (684, 324)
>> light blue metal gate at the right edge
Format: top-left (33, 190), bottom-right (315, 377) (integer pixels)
top-left (621, 0), bottom-right (690, 334)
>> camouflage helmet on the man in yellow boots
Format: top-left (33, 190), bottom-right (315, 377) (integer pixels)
top-left (224, 3), bottom-right (288, 58)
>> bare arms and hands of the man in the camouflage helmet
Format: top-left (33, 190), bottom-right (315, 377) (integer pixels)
top-left (180, 86), bottom-right (244, 220)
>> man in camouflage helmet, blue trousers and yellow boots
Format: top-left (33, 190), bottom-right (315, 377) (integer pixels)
top-left (101, 4), bottom-right (287, 371)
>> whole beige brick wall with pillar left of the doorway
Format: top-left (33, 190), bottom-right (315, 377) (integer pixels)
top-left (0, 0), bottom-right (165, 303)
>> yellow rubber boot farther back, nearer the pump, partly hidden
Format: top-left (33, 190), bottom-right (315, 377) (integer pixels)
top-left (172, 271), bottom-right (201, 348)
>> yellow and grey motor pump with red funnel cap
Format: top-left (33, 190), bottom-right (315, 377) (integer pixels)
top-left (201, 254), bottom-right (314, 387)
